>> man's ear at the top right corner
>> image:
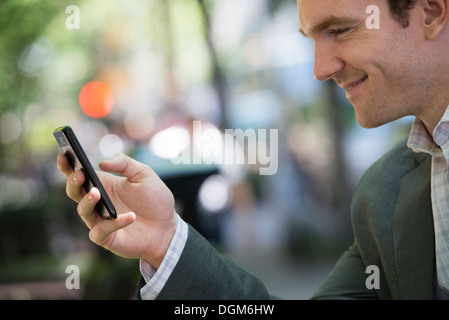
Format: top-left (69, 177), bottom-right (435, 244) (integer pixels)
top-left (420, 0), bottom-right (449, 40)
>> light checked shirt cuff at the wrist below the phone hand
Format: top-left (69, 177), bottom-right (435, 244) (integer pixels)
top-left (136, 215), bottom-right (188, 300)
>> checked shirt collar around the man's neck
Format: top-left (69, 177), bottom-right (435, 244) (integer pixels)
top-left (407, 106), bottom-right (449, 155)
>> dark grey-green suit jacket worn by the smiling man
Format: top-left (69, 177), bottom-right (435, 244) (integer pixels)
top-left (138, 141), bottom-right (435, 299)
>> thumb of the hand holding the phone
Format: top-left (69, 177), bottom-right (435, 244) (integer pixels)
top-left (98, 153), bottom-right (153, 182)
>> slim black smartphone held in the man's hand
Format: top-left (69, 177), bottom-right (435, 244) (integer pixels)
top-left (53, 126), bottom-right (117, 219)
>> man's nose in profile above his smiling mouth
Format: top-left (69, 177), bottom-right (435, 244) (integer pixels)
top-left (313, 43), bottom-right (345, 81)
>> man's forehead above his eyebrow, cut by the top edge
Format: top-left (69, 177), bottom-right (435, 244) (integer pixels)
top-left (297, 0), bottom-right (372, 31)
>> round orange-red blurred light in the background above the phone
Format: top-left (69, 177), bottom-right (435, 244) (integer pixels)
top-left (79, 81), bottom-right (114, 118)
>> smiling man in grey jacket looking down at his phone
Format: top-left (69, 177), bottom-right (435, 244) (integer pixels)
top-left (58, 0), bottom-right (449, 299)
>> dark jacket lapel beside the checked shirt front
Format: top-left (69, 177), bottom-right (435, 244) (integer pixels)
top-left (392, 154), bottom-right (435, 299)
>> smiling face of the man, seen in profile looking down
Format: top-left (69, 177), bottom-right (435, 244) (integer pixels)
top-left (297, 0), bottom-right (428, 128)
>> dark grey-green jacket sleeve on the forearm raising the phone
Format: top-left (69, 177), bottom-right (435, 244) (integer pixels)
top-left (137, 225), bottom-right (275, 300)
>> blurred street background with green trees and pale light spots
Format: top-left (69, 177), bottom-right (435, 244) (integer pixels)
top-left (0, 0), bottom-right (411, 299)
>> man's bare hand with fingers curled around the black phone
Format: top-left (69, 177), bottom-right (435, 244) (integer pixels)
top-left (57, 154), bottom-right (177, 269)
